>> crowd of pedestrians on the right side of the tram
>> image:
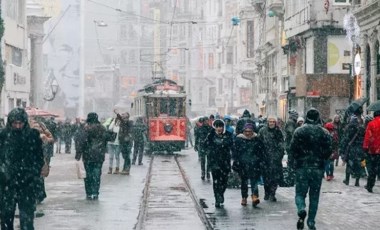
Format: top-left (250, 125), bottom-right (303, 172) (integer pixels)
top-left (194, 104), bottom-right (380, 229)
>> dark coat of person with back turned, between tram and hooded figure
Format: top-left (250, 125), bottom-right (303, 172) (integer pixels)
top-left (75, 123), bottom-right (107, 163)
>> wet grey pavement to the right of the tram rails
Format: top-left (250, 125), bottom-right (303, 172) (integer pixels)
top-left (179, 149), bottom-right (380, 230)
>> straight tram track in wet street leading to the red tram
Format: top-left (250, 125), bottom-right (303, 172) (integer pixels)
top-left (134, 155), bottom-right (213, 230)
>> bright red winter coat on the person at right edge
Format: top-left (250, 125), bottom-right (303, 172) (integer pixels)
top-left (363, 116), bottom-right (380, 155)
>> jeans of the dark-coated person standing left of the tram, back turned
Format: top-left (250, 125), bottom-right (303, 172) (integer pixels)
top-left (83, 162), bottom-right (103, 196)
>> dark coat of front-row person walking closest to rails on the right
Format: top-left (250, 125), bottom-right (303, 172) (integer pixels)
top-left (201, 129), bottom-right (233, 172)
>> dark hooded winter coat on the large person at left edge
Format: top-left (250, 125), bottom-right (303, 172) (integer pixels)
top-left (0, 108), bottom-right (44, 196)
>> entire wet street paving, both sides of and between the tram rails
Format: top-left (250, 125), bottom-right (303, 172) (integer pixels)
top-left (31, 149), bottom-right (380, 230)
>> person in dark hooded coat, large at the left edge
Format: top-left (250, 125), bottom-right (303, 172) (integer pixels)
top-left (0, 108), bottom-right (44, 230)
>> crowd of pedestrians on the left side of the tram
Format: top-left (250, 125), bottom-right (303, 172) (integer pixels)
top-left (0, 108), bottom-right (147, 230)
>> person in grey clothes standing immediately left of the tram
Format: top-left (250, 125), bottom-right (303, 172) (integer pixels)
top-left (132, 117), bottom-right (147, 165)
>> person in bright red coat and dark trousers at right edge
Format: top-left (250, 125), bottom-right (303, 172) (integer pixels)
top-left (363, 110), bottom-right (380, 193)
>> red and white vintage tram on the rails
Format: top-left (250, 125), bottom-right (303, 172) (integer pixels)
top-left (131, 79), bottom-right (186, 154)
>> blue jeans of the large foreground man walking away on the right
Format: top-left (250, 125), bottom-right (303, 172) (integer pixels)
top-left (295, 168), bottom-right (324, 226)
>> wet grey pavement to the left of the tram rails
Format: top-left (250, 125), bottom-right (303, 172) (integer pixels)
top-left (35, 154), bottom-right (149, 230)
